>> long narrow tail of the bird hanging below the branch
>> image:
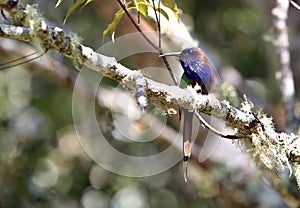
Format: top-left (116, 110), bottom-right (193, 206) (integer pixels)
top-left (182, 109), bottom-right (193, 182)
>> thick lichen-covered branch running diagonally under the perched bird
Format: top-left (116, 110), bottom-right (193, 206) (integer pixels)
top-left (0, 1), bottom-right (300, 205)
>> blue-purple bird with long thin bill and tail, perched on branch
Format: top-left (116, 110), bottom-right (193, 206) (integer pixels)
top-left (160, 47), bottom-right (214, 182)
